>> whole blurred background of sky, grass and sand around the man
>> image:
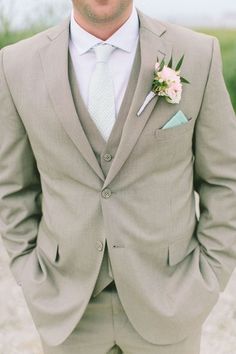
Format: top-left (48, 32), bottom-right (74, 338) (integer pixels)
top-left (0, 0), bottom-right (236, 354)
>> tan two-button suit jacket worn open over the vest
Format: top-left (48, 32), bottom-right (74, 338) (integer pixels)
top-left (0, 12), bottom-right (236, 345)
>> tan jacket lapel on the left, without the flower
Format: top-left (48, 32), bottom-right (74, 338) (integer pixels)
top-left (40, 20), bottom-right (105, 181)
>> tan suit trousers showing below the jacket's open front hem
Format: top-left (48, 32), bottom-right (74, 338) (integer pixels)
top-left (42, 283), bottom-right (201, 354)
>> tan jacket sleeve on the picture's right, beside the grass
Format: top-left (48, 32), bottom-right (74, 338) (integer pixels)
top-left (194, 38), bottom-right (236, 291)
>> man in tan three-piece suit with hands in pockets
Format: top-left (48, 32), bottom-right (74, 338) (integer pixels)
top-left (0, 0), bottom-right (236, 354)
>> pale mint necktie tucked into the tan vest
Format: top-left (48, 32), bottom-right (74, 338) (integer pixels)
top-left (88, 43), bottom-right (116, 141)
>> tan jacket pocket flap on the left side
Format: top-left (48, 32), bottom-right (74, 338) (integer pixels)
top-left (37, 232), bottom-right (59, 262)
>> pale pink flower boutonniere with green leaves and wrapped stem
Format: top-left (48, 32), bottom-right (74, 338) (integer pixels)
top-left (137, 55), bottom-right (189, 117)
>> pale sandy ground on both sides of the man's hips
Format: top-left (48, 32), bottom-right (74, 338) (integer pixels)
top-left (0, 235), bottom-right (236, 354)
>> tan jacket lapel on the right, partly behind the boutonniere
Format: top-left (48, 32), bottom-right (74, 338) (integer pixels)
top-left (103, 12), bottom-right (172, 188)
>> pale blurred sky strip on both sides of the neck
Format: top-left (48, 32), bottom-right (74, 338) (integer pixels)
top-left (0, 0), bottom-right (236, 27)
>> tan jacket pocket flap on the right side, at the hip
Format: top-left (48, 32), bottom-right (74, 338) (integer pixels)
top-left (168, 237), bottom-right (199, 265)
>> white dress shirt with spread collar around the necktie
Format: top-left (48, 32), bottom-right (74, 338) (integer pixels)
top-left (69, 7), bottom-right (139, 116)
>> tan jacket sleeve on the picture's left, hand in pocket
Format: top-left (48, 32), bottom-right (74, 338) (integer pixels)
top-left (0, 50), bottom-right (41, 281)
